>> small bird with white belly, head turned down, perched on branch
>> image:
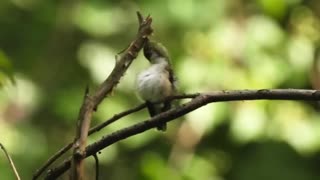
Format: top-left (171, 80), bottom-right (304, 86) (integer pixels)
top-left (137, 40), bottom-right (177, 131)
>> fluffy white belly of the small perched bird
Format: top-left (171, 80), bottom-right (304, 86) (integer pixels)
top-left (138, 71), bottom-right (172, 102)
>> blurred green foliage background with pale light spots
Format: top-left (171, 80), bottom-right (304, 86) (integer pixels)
top-left (0, 0), bottom-right (320, 180)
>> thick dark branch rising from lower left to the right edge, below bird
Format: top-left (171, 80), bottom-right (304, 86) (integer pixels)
top-left (46, 89), bottom-right (320, 179)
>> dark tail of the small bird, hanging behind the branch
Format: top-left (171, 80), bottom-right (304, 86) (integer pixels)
top-left (146, 102), bottom-right (171, 131)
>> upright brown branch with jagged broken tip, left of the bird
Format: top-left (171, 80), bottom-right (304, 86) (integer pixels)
top-left (33, 12), bottom-right (153, 180)
